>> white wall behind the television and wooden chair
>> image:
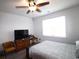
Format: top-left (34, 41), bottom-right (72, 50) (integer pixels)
top-left (0, 12), bottom-right (33, 43)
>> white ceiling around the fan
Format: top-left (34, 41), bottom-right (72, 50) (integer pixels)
top-left (0, 0), bottom-right (79, 17)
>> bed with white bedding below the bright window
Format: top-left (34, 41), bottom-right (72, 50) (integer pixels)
top-left (30, 41), bottom-right (75, 59)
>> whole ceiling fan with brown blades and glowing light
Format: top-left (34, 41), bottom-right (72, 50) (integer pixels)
top-left (16, 0), bottom-right (49, 14)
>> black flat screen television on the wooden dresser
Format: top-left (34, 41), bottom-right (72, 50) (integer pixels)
top-left (14, 30), bottom-right (29, 40)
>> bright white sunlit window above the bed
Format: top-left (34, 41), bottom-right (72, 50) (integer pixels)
top-left (42, 16), bottom-right (66, 37)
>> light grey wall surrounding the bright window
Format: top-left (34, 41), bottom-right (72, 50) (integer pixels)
top-left (34, 6), bottom-right (79, 43)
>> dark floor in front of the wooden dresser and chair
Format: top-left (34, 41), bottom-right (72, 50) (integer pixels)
top-left (0, 50), bottom-right (26, 59)
